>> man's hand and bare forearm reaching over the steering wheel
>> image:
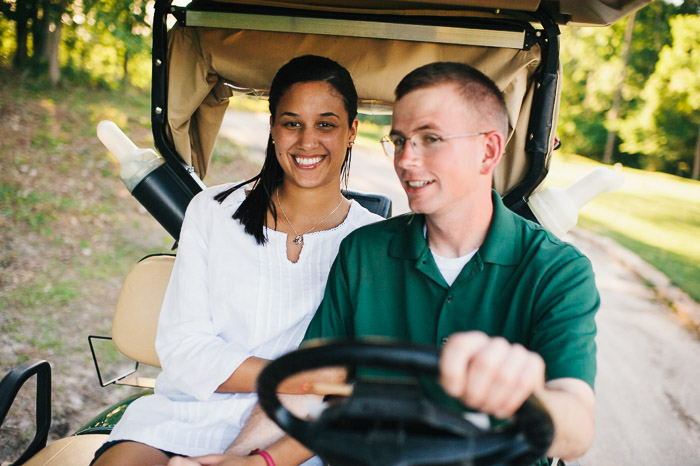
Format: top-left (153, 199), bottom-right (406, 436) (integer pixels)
top-left (440, 332), bottom-right (595, 461)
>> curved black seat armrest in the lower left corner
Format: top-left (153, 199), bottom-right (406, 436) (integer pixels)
top-left (0, 359), bottom-right (51, 465)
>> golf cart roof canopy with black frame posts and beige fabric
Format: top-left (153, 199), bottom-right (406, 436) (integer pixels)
top-left (152, 0), bottom-right (649, 211)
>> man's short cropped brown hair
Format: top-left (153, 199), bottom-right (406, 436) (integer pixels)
top-left (395, 62), bottom-right (508, 139)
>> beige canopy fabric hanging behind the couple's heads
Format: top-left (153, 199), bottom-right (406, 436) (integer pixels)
top-left (167, 26), bottom-right (553, 194)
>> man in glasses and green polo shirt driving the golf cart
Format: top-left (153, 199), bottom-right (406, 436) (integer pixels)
top-left (170, 63), bottom-right (599, 464)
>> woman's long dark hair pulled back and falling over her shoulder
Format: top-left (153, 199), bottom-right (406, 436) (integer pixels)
top-left (214, 55), bottom-right (357, 244)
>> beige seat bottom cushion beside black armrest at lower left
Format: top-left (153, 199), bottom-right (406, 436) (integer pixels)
top-left (24, 434), bottom-right (108, 466)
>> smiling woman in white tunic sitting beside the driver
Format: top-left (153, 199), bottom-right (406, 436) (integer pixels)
top-left (94, 55), bottom-right (380, 466)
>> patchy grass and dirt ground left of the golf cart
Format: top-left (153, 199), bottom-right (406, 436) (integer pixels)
top-left (0, 70), bottom-right (172, 369)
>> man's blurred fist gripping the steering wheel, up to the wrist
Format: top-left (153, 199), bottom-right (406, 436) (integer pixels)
top-left (440, 332), bottom-right (544, 418)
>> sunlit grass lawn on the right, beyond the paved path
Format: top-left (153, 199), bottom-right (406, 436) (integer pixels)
top-left (546, 153), bottom-right (700, 301)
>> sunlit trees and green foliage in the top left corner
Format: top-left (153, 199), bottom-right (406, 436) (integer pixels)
top-left (0, 0), bottom-right (153, 89)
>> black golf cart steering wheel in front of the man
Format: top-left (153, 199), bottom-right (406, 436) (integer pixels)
top-left (258, 341), bottom-right (554, 466)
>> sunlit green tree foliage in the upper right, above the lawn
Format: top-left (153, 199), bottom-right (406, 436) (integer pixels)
top-left (557, 1), bottom-right (700, 180)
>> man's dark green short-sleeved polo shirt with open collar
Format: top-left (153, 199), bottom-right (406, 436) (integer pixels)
top-left (305, 191), bottom-right (599, 387)
